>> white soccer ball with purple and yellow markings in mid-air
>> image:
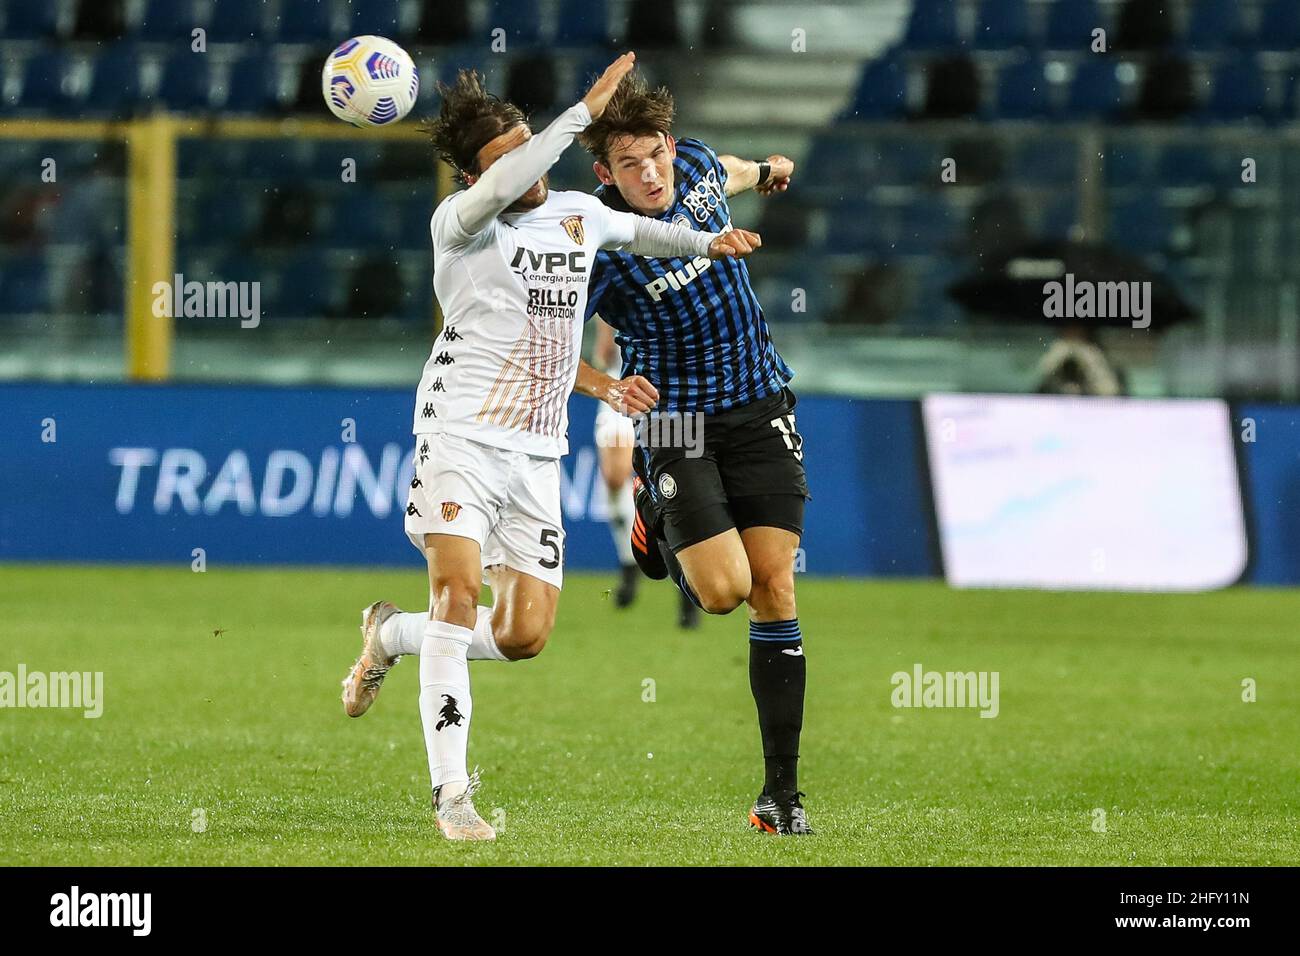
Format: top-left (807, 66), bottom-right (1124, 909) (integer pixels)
top-left (321, 36), bottom-right (420, 126)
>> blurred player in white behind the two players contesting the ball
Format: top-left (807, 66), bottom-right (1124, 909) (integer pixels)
top-left (593, 316), bottom-right (699, 628)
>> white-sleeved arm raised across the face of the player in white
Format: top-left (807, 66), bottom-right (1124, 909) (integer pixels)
top-left (456, 53), bottom-right (636, 235)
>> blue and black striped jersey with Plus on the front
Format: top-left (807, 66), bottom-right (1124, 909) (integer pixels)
top-left (586, 139), bottom-right (794, 414)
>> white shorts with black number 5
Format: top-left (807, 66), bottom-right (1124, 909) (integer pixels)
top-left (406, 433), bottom-right (564, 588)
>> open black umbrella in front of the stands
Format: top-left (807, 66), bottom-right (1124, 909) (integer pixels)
top-left (948, 239), bottom-right (1197, 332)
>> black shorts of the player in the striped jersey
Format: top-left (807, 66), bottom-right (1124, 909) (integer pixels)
top-left (633, 389), bottom-right (810, 553)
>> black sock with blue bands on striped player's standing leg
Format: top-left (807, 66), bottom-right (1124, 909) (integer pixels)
top-left (749, 619), bottom-right (807, 797)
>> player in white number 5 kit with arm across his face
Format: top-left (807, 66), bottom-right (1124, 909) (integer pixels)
top-left (343, 53), bottom-right (759, 840)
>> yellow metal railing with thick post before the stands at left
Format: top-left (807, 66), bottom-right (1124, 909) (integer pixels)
top-left (0, 120), bottom-right (452, 381)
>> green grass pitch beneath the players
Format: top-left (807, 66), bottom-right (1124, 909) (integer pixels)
top-left (0, 566), bottom-right (1300, 865)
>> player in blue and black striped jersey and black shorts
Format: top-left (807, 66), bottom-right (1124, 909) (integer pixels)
top-left (577, 73), bottom-right (811, 835)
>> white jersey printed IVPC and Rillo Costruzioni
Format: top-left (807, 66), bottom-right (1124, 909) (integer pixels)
top-left (413, 191), bottom-right (634, 458)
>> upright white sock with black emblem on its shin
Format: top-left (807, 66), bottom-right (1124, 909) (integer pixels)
top-left (420, 620), bottom-right (473, 803)
